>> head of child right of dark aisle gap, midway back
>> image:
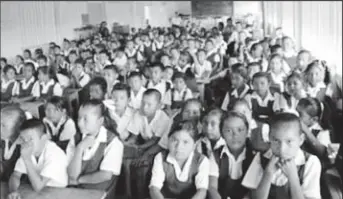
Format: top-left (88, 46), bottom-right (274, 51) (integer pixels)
top-left (230, 63), bottom-right (248, 89)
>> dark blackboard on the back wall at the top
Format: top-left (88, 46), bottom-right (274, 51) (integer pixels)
top-left (192, 1), bottom-right (233, 17)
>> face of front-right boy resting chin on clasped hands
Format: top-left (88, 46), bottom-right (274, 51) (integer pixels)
top-left (269, 123), bottom-right (304, 160)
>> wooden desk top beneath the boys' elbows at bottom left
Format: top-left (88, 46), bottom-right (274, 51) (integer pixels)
top-left (0, 182), bottom-right (106, 199)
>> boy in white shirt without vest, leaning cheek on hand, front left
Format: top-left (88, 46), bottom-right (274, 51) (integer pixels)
top-left (9, 119), bottom-right (68, 198)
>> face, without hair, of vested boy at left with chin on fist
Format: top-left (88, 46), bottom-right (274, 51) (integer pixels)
top-left (77, 106), bottom-right (104, 135)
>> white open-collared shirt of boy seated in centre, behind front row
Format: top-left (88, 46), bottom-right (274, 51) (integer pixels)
top-left (128, 110), bottom-right (172, 140)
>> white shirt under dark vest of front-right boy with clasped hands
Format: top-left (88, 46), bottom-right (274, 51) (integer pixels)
top-left (242, 149), bottom-right (322, 199)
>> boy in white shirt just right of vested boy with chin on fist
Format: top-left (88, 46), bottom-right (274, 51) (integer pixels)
top-left (109, 83), bottom-right (135, 142)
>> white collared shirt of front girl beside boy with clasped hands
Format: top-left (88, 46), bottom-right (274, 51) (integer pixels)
top-left (210, 145), bottom-right (246, 180)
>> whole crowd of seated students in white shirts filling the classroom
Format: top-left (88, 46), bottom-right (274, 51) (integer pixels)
top-left (0, 18), bottom-right (343, 199)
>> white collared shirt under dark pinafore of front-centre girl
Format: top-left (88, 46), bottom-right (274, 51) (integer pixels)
top-left (149, 152), bottom-right (209, 189)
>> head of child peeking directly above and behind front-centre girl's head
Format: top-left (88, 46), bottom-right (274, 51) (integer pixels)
top-left (181, 98), bottom-right (202, 120)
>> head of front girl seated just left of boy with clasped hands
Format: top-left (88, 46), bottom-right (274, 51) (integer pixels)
top-left (220, 112), bottom-right (249, 151)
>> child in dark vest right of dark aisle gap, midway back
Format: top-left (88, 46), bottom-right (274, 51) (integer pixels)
top-left (221, 63), bottom-right (250, 111)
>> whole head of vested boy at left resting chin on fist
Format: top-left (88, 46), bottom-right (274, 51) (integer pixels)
top-left (77, 99), bottom-right (105, 136)
